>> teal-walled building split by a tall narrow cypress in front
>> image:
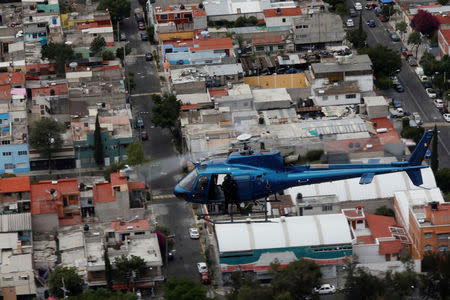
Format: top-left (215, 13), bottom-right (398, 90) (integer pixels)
top-left (71, 108), bottom-right (133, 168)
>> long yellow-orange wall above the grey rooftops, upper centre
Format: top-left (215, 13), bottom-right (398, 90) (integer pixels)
top-left (244, 73), bottom-right (309, 89)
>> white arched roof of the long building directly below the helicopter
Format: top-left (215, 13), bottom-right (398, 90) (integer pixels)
top-left (215, 214), bottom-right (351, 253)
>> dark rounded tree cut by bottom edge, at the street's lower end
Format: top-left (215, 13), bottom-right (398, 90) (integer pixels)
top-left (163, 277), bottom-right (207, 300)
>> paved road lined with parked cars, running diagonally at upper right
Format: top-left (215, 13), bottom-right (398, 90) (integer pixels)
top-left (348, 1), bottom-right (450, 168)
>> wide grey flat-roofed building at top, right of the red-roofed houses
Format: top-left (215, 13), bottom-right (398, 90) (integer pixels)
top-left (292, 11), bottom-right (345, 51)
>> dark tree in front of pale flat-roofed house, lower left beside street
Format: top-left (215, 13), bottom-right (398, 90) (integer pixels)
top-left (114, 255), bottom-right (147, 286)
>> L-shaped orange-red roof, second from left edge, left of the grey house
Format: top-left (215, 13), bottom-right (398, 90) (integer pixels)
top-left (30, 178), bottom-right (80, 215)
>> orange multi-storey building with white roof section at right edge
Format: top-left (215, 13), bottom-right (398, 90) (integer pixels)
top-left (394, 189), bottom-right (450, 259)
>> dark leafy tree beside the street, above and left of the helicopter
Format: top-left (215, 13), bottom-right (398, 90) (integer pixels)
top-left (152, 94), bottom-right (181, 134)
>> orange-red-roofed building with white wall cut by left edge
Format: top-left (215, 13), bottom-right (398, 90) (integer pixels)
top-left (0, 176), bottom-right (31, 214)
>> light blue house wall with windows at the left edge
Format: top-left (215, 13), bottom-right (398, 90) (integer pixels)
top-left (0, 144), bottom-right (30, 173)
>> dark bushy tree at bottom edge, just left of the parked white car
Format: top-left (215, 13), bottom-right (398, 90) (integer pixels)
top-left (272, 258), bottom-right (322, 299)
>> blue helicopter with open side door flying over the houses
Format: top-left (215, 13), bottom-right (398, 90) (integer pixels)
top-left (174, 130), bottom-right (434, 204)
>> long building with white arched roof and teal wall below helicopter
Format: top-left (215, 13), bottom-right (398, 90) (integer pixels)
top-left (214, 214), bottom-right (352, 282)
